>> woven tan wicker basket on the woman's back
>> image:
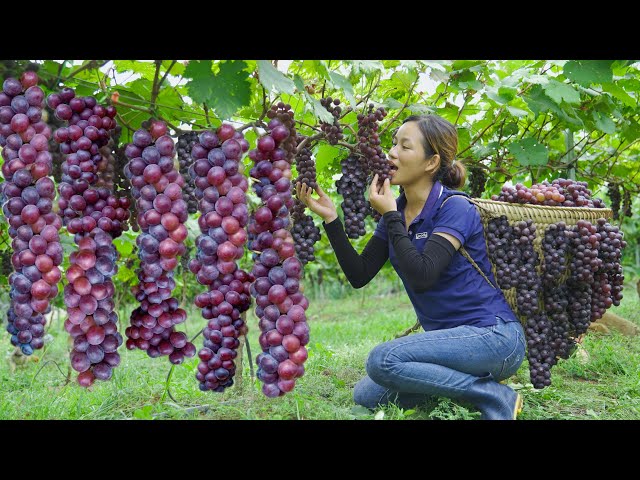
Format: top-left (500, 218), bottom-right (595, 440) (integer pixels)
top-left (471, 198), bottom-right (613, 324)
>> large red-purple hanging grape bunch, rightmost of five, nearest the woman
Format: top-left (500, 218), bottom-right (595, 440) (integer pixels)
top-left (249, 102), bottom-right (309, 397)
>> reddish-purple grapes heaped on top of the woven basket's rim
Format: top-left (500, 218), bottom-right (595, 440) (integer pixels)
top-left (491, 178), bottom-right (605, 208)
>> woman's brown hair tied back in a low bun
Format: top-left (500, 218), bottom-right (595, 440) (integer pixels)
top-left (402, 115), bottom-right (467, 189)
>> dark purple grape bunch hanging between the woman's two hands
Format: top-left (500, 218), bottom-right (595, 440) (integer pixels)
top-left (336, 155), bottom-right (370, 238)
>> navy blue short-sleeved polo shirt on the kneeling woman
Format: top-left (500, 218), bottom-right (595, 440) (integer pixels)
top-left (374, 182), bottom-right (518, 330)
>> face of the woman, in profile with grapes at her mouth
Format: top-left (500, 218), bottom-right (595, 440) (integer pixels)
top-left (389, 122), bottom-right (437, 187)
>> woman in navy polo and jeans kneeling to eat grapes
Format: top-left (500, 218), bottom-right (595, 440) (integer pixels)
top-left (296, 115), bottom-right (525, 420)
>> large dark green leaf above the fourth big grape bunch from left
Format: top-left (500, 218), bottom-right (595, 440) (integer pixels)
top-left (184, 60), bottom-right (251, 119)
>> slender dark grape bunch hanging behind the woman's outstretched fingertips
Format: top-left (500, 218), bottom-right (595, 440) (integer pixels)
top-left (291, 136), bottom-right (320, 266)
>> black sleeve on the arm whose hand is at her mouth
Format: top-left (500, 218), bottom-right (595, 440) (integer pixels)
top-left (384, 210), bottom-right (456, 293)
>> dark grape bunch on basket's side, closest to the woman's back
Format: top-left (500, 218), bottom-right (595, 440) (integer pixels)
top-left (485, 215), bottom-right (522, 290)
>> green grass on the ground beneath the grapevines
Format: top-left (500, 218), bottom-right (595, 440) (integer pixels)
top-left (0, 285), bottom-right (640, 420)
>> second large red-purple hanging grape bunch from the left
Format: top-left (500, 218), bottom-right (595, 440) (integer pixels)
top-left (47, 88), bottom-right (129, 387)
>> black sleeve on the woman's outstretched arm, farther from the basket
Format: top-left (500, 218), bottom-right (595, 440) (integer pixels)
top-left (322, 218), bottom-right (389, 288)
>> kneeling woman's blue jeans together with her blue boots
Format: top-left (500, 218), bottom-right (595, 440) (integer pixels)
top-left (353, 317), bottom-right (525, 420)
